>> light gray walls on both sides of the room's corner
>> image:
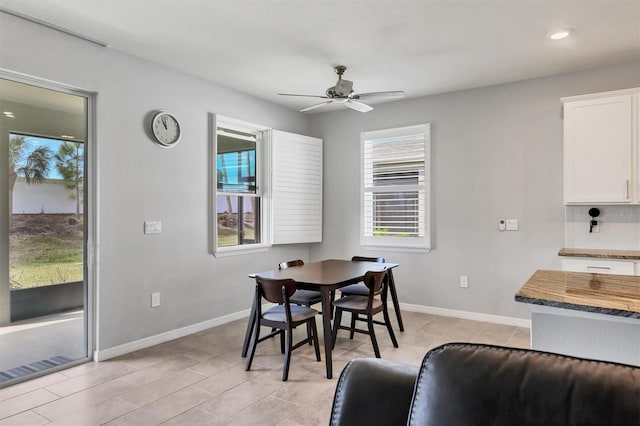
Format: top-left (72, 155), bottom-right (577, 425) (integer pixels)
top-left (0, 13), bottom-right (640, 349)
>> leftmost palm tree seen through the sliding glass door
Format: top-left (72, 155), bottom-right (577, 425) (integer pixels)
top-left (9, 134), bottom-right (51, 221)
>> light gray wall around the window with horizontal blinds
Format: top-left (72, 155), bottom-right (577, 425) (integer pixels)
top-left (311, 62), bottom-right (640, 318)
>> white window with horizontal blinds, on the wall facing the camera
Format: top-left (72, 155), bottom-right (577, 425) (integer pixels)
top-left (360, 124), bottom-right (431, 250)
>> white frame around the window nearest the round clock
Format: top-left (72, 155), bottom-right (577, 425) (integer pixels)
top-left (209, 114), bottom-right (271, 257)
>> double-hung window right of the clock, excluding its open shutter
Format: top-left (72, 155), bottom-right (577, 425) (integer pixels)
top-left (214, 116), bottom-right (268, 254)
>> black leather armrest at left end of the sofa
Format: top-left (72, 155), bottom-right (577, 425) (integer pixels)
top-left (330, 358), bottom-right (419, 426)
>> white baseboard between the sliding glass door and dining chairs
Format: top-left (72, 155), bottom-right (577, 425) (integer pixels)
top-left (93, 309), bottom-right (250, 361)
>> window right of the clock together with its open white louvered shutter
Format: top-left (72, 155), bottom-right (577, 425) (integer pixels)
top-left (209, 114), bottom-right (322, 256)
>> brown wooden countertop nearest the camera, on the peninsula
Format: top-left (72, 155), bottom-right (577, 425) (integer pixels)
top-left (515, 270), bottom-right (640, 319)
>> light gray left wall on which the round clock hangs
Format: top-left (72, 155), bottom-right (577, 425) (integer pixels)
top-left (0, 13), bottom-right (309, 350)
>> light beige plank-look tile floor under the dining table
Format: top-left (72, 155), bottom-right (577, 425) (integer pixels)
top-left (0, 312), bottom-right (529, 426)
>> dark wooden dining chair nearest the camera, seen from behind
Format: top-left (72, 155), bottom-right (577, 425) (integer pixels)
top-left (246, 276), bottom-right (320, 382)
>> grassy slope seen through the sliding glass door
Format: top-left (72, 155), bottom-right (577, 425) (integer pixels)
top-left (9, 235), bottom-right (83, 288)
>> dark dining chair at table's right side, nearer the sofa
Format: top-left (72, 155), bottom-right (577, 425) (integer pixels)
top-left (332, 269), bottom-right (398, 358)
